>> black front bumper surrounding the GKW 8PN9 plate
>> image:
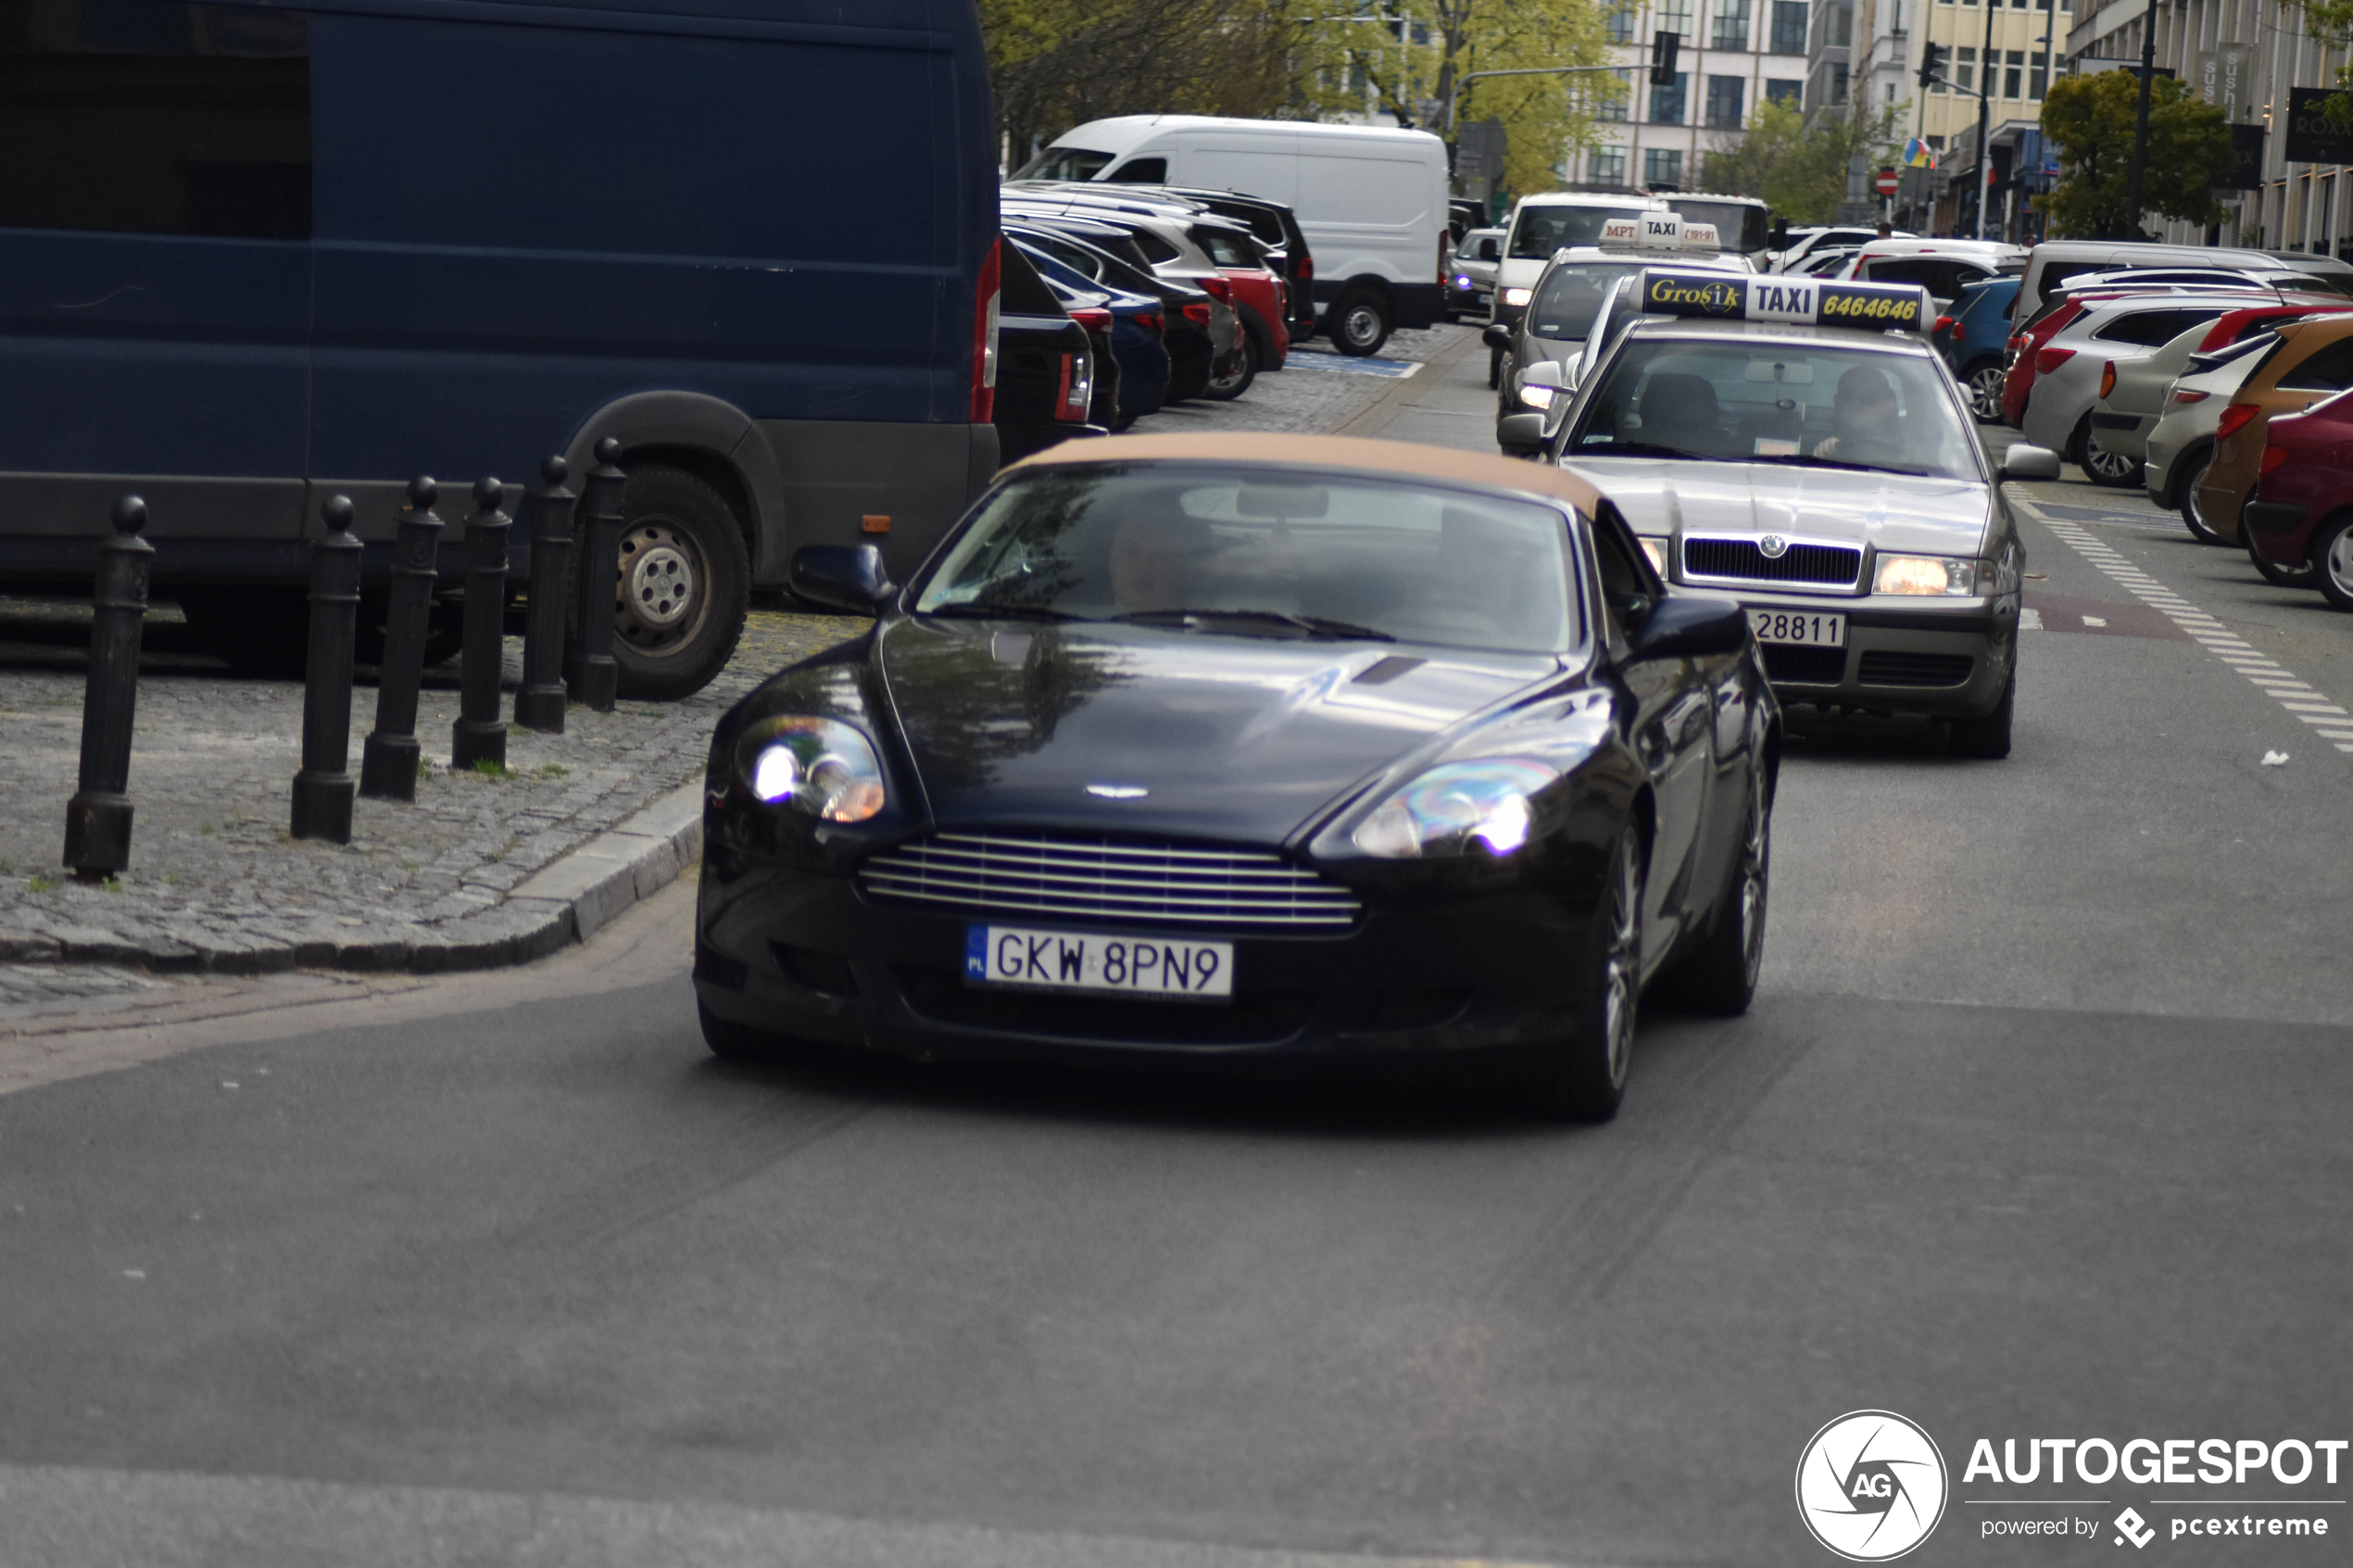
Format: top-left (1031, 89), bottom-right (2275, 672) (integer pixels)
top-left (694, 837), bottom-right (1591, 1062)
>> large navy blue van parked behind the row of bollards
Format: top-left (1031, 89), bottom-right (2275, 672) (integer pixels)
top-left (0, 0), bottom-right (998, 696)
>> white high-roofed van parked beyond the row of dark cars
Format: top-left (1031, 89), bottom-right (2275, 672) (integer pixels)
top-left (1014, 115), bottom-right (1452, 355)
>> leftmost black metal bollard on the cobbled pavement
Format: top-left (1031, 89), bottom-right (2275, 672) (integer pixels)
top-left (66, 496), bottom-right (156, 882)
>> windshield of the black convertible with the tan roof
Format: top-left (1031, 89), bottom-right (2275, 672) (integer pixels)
top-left (915, 463), bottom-right (1583, 654)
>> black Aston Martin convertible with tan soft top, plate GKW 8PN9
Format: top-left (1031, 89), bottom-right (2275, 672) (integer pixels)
top-left (694, 435), bottom-right (1781, 1119)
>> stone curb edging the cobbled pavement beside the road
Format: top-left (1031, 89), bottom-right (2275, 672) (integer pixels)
top-left (0, 783), bottom-right (703, 975)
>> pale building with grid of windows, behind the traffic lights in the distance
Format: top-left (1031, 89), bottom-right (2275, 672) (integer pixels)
top-left (1567, 0), bottom-right (1809, 191)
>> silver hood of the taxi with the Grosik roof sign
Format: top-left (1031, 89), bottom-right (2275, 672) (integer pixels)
top-left (1563, 458), bottom-right (1993, 555)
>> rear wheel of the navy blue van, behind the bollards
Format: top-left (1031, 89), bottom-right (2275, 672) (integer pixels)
top-left (611, 466), bottom-right (750, 703)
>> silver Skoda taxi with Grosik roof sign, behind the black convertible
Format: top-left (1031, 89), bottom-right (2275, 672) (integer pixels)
top-left (1551, 268), bottom-right (2059, 757)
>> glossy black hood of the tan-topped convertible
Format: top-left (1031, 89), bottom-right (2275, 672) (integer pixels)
top-left (875, 619), bottom-right (1560, 842)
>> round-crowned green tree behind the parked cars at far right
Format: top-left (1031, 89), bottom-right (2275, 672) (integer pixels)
top-left (2035, 70), bottom-right (2238, 240)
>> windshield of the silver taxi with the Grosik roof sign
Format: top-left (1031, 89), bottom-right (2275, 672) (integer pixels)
top-left (1567, 339), bottom-right (1983, 480)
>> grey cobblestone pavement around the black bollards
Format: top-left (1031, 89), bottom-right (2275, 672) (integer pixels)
top-left (0, 599), bottom-right (862, 972)
